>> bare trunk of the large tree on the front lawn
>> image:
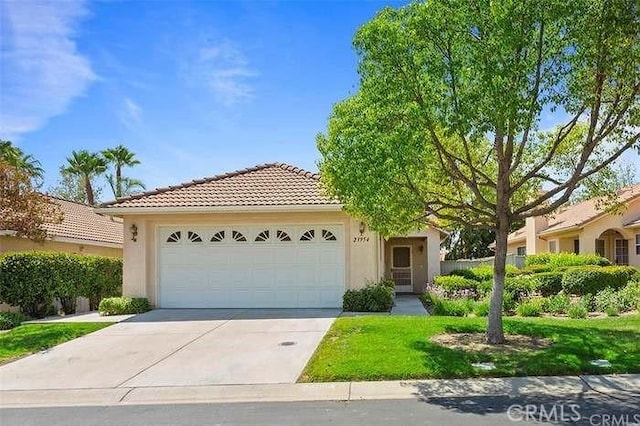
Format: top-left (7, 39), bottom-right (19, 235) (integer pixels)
top-left (487, 217), bottom-right (509, 345)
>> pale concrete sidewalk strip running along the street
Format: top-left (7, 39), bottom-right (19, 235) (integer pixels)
top-left (0, 374), bottom-right (640, 408)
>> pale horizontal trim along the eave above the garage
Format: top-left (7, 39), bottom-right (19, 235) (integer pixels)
top-left (93, 204), bottom-right (343, 216)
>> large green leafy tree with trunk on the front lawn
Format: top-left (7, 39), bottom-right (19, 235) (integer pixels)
top-left (318, 0), bottom-right (640, 344)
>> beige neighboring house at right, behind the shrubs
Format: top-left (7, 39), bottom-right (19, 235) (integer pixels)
top-left (507, 184), bottom-right (640, 268)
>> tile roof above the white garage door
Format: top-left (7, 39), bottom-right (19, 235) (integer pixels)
top-left (100, 163), bottom-right (340, 208)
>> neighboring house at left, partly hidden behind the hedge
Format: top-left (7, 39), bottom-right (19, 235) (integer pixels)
top-left (0, 196), bottom-right (122, 257)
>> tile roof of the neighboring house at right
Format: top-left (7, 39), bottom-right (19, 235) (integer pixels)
top-left (509, 184), bottom-right (640, 241)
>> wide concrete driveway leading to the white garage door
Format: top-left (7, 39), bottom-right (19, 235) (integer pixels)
top-left (0, 309), bottom-right (340, 390)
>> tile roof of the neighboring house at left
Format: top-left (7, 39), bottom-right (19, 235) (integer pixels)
top-left (44, 196), bottom-right (123, 244)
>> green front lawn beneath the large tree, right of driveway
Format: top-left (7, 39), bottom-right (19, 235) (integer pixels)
top-left (300, 315), bottom-right (640, 382)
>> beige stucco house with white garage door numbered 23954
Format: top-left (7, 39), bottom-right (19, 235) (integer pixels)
top-left (97, 163), bottom-right (440, 308)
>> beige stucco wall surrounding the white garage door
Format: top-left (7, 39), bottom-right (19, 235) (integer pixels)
top-left (123, 212), bottom-right (382, 305)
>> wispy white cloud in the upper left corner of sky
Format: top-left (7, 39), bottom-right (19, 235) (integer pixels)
top-left (0, 0), bottom-right (97, 139)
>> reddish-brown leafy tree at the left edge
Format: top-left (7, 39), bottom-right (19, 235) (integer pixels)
top-left (0, 159), bottom-right (62, 241)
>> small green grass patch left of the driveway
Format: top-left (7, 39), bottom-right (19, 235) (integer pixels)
top-left (0, 322), bottom-right (111, 364)
